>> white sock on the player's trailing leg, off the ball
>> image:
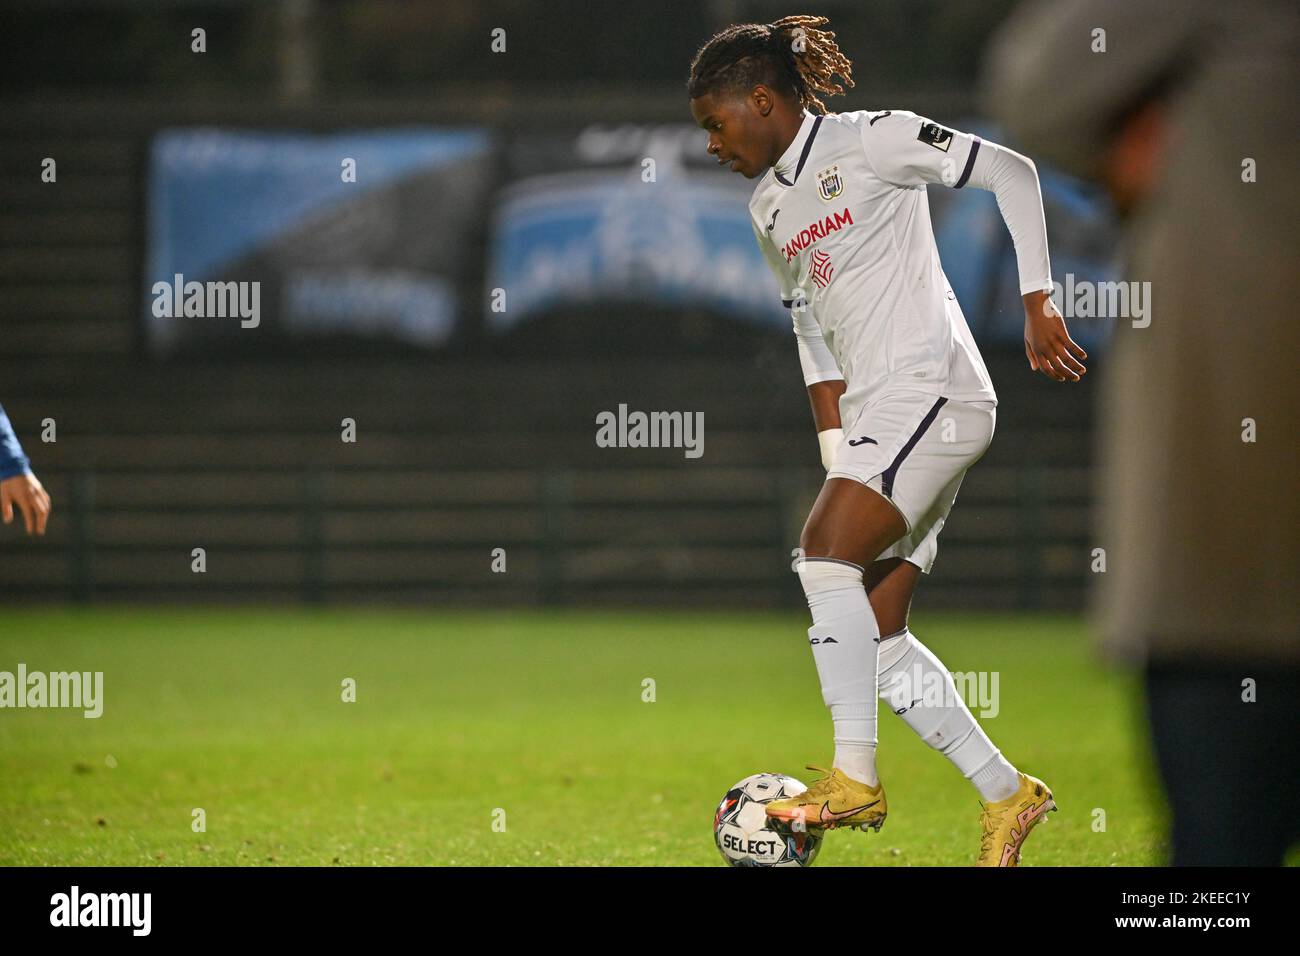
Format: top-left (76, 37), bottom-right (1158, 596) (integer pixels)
top-left (879, 627), bottom-right (1021, 803)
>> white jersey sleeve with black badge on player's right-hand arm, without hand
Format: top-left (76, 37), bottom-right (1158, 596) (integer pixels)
top-left (862, 111), bottom-right (1052, 295)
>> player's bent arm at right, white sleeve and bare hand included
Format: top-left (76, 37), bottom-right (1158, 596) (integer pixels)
top-left (862, 111), bottom-right (1088, 381)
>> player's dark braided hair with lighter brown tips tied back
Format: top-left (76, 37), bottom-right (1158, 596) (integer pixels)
top-left (686, 16), bottom-right (853, 113)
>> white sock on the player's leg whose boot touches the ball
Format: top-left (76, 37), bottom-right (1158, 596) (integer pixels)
top-left (798, 558), bottom-right (880, 787)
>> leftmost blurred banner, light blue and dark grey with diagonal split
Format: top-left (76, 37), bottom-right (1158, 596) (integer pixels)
top-left (143, 127), bottom-right (493, 354)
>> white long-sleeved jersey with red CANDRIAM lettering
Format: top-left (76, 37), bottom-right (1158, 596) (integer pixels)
top-left (749, 111), bottom-right (1052, 427)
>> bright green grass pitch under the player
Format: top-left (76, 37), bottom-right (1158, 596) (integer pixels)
top-left (0, 609), bottom-right (1166, 866)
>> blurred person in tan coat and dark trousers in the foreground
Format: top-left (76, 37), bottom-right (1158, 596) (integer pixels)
top-left (983, 0), bottom-right (1300, 865)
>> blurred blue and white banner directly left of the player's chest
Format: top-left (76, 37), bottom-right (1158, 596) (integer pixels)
top-left (484, 124), bottom-right (790, 337)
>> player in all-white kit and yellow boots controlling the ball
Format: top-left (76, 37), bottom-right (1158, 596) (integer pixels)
top-left (688, 17), bottom-right (1087, 866)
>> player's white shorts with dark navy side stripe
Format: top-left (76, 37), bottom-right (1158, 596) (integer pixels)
top-left (826, 392), bottom-right (997, 574)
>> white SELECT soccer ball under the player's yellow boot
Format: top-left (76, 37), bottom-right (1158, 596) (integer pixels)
top-left (714, 774), bottom-right (822, 866)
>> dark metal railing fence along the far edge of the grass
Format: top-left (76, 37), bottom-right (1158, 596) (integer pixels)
top-left (0, 463), bottom-right (1091, 609)
